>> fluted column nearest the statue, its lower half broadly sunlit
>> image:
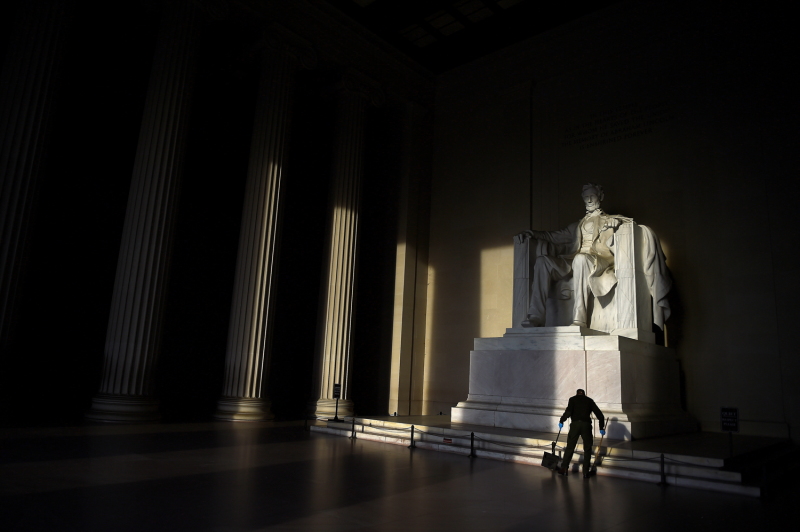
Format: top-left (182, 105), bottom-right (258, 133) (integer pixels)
top-left (310, 71), bottom-right (382, 417)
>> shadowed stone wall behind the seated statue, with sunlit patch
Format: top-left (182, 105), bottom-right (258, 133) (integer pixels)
top-left (423, 2), bottom-right (800, 439)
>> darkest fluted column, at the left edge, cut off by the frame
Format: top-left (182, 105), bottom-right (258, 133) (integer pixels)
top-left (0, 0), bottom-right (67, 346)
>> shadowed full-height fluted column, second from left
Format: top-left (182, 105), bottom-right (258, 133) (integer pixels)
top-left (86, 0), bottom-right (201, 422)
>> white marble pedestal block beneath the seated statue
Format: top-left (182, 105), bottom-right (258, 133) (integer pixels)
top-left (452, 326), bottom-right (697, 440)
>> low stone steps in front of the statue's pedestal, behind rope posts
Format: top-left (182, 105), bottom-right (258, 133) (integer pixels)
top-left (310, 418), bottom-right (761, 497)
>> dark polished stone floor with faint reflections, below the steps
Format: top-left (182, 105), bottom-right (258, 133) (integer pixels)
top-left (0, 422), bottom-right (800, 532)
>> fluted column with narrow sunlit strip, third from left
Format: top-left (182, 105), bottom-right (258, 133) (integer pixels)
top-left (214, 26), bottom-right (316, 421)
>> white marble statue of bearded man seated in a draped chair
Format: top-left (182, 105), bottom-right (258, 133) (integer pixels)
top-left (513, 183), bottom-right (672, 342)
